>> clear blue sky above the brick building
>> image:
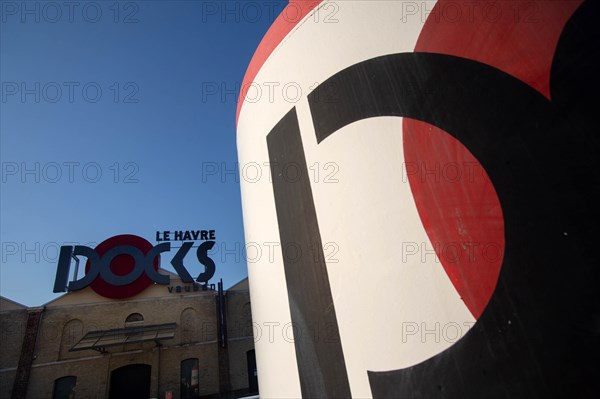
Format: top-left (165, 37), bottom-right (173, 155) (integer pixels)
top-left (0, 0), bottom-right (287, 306)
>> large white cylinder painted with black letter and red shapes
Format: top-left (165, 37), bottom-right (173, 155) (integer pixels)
top-left (237, 0), bottom-right (600, 398)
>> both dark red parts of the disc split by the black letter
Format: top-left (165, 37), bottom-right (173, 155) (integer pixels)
top-left (403, 0), bottom-right (581, 319)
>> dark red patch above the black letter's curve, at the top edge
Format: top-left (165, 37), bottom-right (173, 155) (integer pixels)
top-left (415, 0), bottom-right (583, 98)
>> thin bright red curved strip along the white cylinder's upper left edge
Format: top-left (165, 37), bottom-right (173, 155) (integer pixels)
top-left (235, 0), bottom-right (323, 124)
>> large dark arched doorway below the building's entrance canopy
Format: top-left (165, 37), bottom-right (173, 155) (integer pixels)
top-left (109, 364), bottom-right (151, 399)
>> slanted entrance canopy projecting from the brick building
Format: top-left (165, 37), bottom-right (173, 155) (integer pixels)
top-left (69, 323), bottom-right (177, 352)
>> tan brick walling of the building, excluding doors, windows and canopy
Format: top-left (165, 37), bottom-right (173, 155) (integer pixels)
top-left (0, 287), bottom-right (254, 399)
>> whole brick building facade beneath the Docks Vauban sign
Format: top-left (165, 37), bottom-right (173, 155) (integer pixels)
top-left (0, 271), bottom-right (258, 399)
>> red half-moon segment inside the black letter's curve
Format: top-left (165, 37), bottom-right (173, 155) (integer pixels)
top-left (403, 118), bottom-right (504, 319)
